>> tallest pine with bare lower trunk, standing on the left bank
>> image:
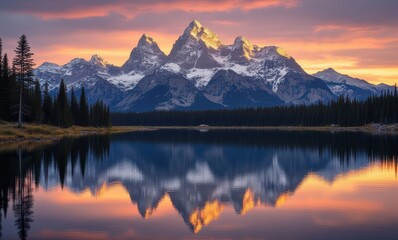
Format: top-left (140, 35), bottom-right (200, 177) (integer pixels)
top-left (13, 35), bottom-right (35, 127)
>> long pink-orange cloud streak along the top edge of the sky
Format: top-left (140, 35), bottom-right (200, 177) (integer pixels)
top-left (8, 0), bottom-right (298, 19)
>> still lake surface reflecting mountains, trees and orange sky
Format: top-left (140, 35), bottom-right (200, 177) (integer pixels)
top-left (0, 130), bottom-right (398, 240)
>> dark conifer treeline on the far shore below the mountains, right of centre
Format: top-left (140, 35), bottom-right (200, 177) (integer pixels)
top-left (111, 90), bottom-right (398, 127)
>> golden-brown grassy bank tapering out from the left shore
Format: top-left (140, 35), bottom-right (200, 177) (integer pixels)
top-left (0, 122), bottom-right (149, 143)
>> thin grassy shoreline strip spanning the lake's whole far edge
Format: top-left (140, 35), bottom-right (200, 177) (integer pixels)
top-left (0, 123), bottom-right (398, 145)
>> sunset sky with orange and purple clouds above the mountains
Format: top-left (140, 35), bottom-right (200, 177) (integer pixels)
top-left (0, 0), bottom-right (398, 84)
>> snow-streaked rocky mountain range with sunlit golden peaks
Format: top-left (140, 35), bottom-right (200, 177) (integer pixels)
top-left (34, 20), bottom-right (392, 112)
